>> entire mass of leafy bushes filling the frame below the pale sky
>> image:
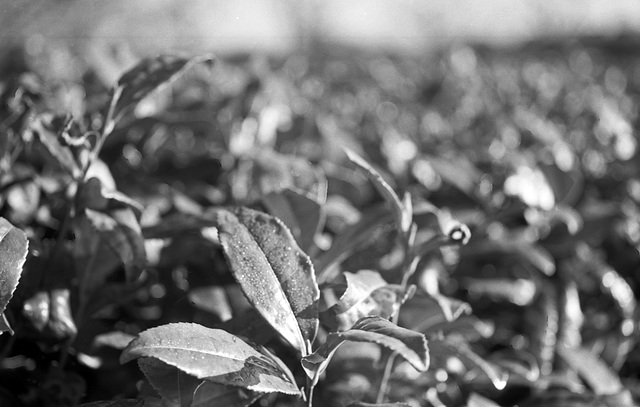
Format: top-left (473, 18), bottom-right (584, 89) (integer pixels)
top-left (0, 39), bottom-right (640, 407)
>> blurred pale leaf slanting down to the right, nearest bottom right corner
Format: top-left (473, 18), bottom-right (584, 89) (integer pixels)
top-left (557, 344), bottom-right (624, 395)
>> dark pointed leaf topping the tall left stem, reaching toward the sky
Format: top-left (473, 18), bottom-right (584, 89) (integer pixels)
top-left (113, 55), bottom-right (214, 122)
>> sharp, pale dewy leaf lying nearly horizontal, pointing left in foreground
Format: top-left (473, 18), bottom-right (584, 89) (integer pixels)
top-left (120, 323), bottom-right (300, 395)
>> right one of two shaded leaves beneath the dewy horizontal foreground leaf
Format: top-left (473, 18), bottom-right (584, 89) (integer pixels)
top-left (191, 381), bottom-right (262, 407)
